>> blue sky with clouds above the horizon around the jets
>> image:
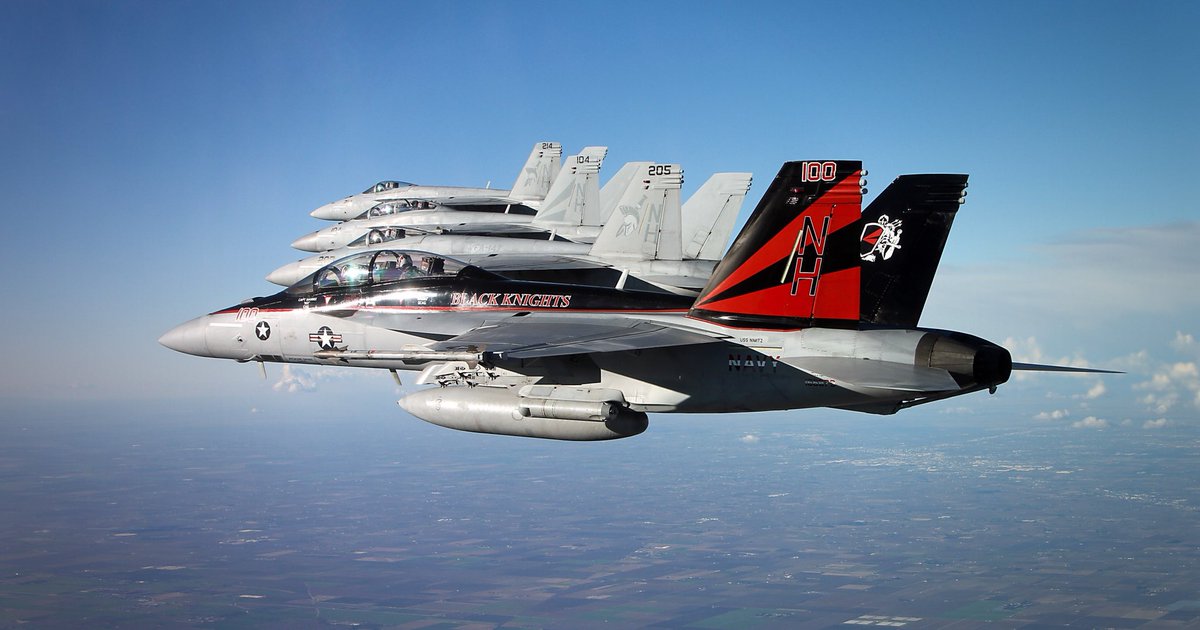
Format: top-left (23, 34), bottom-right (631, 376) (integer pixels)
top-left (0, 1), bottom-right (1200, 433)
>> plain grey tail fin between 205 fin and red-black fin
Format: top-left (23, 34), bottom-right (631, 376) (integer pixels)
top-left (683, 173), bottom-right (750, 260)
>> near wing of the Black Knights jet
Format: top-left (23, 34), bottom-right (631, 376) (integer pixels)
top-left (431, 317), bottom-right (727, 359)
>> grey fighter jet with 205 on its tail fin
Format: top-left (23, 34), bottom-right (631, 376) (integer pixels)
top-left (266, 166), bottom-right (750, 294)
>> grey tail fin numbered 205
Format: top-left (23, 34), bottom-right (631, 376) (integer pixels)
top-left (590, 164), bottom-right (683, 260)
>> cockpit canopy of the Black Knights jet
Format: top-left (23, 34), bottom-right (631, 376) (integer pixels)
top-left (288, 250), bottom-right (493, 293)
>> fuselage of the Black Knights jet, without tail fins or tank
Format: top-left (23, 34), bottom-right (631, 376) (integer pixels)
top-left (160, 253), bottom-right (1007, 413)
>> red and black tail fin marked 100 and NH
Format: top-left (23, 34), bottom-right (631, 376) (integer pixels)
top-left (690, 160), bottom-right (864, 329)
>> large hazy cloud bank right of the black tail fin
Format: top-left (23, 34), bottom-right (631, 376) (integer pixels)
top-left (922, 221), bottom-right (1200, 357)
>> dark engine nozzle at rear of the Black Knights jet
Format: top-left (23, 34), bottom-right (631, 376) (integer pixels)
top-left (917, 332), bottom-right (1013, 388)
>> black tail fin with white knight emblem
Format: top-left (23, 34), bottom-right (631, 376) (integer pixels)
top-left (859, 175), bottom-right (967, 328)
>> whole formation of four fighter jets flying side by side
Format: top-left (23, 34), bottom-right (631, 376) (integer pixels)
top-left (160, 142), bottom-right (1113, 440)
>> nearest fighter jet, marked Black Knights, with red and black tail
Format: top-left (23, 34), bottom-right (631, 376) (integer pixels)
top-left (160, 161), bottom-right (1100, 440)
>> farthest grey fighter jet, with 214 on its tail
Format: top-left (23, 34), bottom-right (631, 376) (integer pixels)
top-left (310, 142), bottom-right (563, 221)
